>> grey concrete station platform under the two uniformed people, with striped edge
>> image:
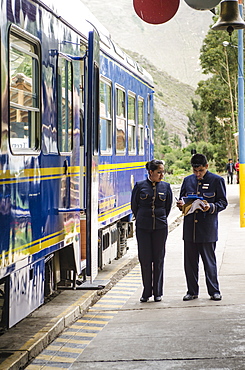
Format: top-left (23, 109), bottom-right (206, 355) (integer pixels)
top-left (0, 185), bottom-right (245, 370)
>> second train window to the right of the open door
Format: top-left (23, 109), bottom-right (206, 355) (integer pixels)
top-left (115, 84), bottom-right (127, 155)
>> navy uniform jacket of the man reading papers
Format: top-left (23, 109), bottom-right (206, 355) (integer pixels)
top-left (180, 171), bottom-right (228, 243)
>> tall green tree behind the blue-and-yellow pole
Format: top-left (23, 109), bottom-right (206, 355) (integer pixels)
top-left (188, 20), bottom-right (237, 161)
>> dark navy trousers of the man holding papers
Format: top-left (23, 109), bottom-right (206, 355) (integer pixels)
top-left (184, 241), bottom-right (220, 296)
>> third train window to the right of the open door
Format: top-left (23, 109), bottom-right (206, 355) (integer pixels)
top-left (127, 91), bottom-right (136, 155)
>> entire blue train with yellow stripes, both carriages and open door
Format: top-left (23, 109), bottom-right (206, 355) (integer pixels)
top-left (0, 0), bottom-right (152, 328)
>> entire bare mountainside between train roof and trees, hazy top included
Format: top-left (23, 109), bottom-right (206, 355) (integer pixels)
top-left (81, 0), bottom-right (213, 145)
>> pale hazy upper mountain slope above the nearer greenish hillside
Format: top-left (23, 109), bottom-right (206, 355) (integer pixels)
top-left (82, 0), bottom-right (213, 87)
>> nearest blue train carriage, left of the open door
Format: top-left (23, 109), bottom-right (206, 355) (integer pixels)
top-left (0, 0), bottom-right (93, 328)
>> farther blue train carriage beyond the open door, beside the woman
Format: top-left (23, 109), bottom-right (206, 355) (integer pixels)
top-left (98, 34), bottom-right (153, 268)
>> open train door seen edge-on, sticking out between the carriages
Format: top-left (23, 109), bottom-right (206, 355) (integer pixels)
top-left (86, 31), bottom-right (100, 282)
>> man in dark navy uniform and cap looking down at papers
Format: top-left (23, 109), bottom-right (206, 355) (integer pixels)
top-left (177, 154), bottom-right (228, 301)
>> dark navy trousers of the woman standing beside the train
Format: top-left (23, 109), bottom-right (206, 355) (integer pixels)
top-left (136, 226), bottom-right (168, 298)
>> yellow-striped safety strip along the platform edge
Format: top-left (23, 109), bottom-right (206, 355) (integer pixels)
top-left (26, 265), bottom-right (141, 370)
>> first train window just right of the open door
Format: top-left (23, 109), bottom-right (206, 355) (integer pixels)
top-left (99, 76), bottom-right (113, 155)
